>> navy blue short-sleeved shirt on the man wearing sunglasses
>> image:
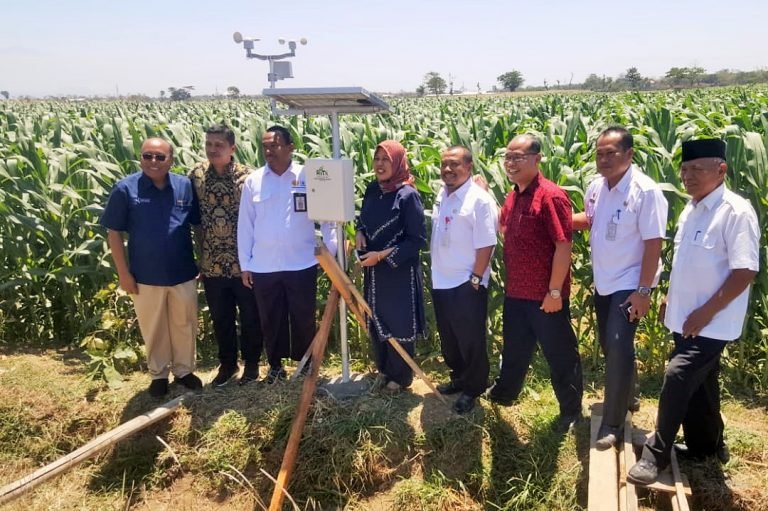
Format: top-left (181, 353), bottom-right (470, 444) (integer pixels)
top-left (100, 172), bottom-right (200, 286)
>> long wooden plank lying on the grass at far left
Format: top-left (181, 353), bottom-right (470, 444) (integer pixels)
top-left (0, 392), bottom-right (194, 504)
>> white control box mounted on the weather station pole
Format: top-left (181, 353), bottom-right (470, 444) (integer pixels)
top-left (304, 159), bottom-right (355, 222)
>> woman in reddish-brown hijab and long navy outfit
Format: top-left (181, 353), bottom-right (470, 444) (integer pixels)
top-left (355, 140), bottom-right (427, 393)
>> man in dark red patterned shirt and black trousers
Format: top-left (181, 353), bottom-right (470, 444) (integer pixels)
top-left (488, 134), bottom-right (583, 430)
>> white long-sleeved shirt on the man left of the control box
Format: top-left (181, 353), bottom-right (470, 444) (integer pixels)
top-left (237, 163), bottom-right (337, 273)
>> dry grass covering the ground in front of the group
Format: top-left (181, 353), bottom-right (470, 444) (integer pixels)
top-left (0, 352), bottom-right (768, 511)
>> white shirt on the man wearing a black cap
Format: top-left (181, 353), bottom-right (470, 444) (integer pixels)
top-left (664, 184), bottom-right (760, 341)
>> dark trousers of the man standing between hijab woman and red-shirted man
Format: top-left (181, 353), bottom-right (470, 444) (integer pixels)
top-left (432, 281), bottom-right (489, 397)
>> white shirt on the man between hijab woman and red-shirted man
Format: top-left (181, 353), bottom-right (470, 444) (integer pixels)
top-left (430, 176), bottom-right (498, 289)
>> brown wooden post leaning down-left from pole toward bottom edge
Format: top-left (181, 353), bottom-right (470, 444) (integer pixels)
top-left (269, 288), bottom-right (339, 511)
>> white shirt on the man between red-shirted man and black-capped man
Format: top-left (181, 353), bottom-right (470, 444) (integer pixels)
top-left (584, 165), bottom-right (668, 295)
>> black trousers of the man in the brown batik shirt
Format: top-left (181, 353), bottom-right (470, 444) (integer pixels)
top-left (203, 277), bottom-right (263, 366)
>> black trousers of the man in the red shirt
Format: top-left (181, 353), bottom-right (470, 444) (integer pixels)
top-left (493, 297), bottom-right (584, 415)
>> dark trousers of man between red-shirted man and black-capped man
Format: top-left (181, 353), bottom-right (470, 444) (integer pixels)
top-left (595, 289), bottom-right (637, 428)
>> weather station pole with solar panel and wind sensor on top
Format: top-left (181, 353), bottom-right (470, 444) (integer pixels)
top-left (233, 32), bottom-right (389, 383)
